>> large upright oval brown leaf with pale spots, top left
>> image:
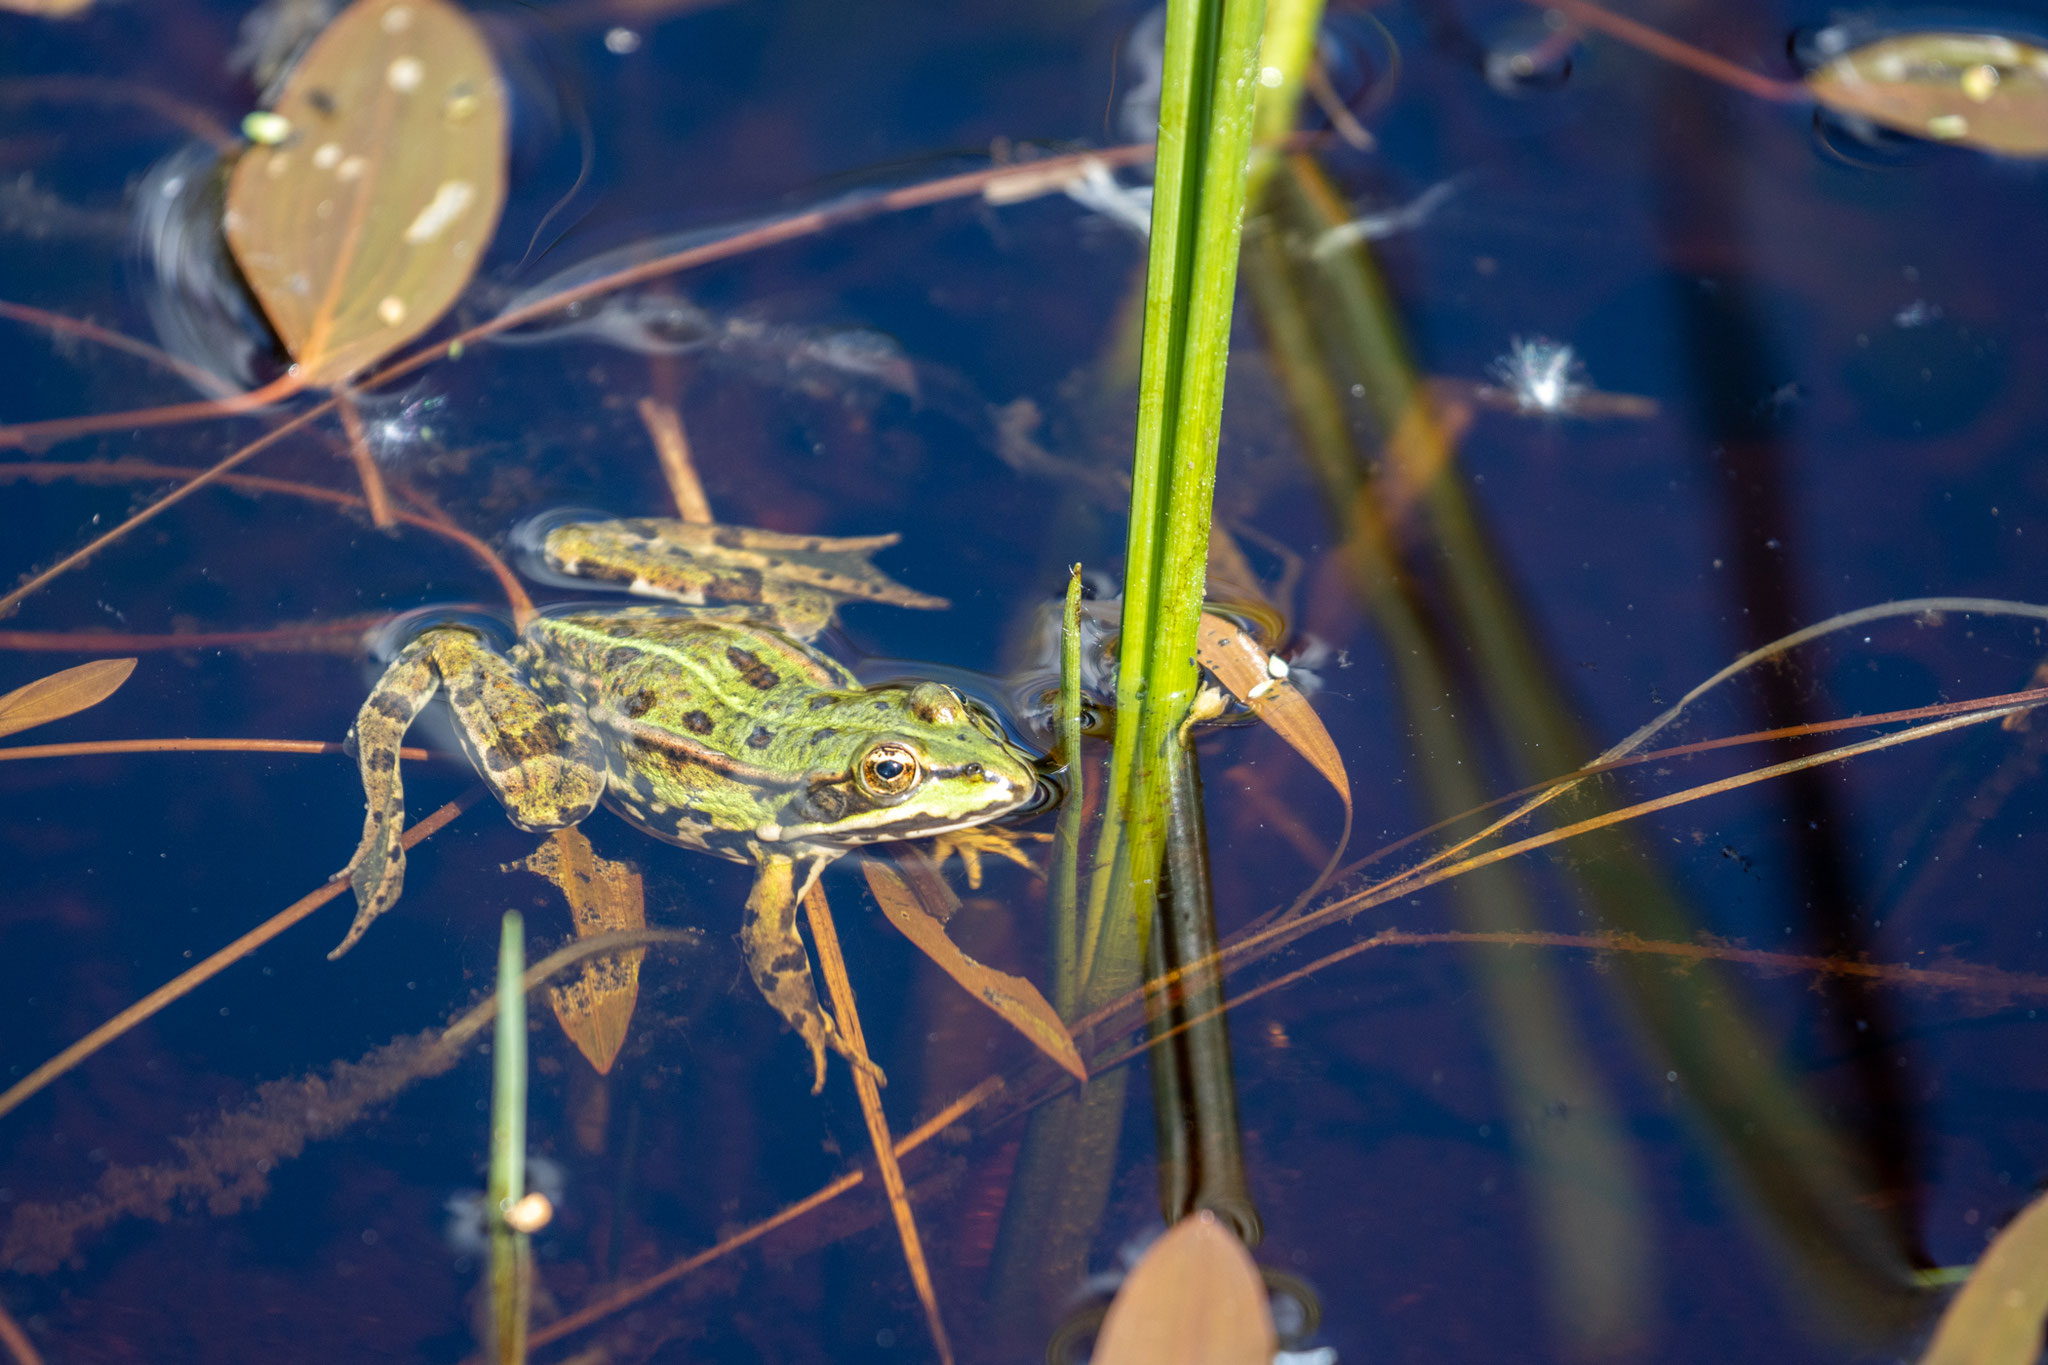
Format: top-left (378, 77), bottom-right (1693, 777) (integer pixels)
top-left (223, 0), bottom-right (506, 387)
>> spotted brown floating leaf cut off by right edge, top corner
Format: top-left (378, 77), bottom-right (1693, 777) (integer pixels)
top-left (1806, 33), bottom-right (2048, 158)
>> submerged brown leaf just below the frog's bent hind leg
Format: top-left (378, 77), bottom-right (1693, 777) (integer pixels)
top-left (514, 825), bottom-right (647, 1076)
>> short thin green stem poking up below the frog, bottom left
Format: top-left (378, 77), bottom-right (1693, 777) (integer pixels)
top-left (487, 911), bottom-right (532, 1365)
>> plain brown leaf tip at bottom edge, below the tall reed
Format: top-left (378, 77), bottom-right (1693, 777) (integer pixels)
top-left (1094, 1209), bottom-right (1278, 1365)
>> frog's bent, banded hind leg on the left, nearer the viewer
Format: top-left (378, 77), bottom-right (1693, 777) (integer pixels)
top-left (328, 626), bottom-right (604, 958)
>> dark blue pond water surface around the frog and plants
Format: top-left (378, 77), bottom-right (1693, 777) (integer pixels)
top-left (0, 0), bottom-right (2048, 1361)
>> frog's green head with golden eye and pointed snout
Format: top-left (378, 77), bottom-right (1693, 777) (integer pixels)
top-left (754, 681), bottom-right (1038, 847)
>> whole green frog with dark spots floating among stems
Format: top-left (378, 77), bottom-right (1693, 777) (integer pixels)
top-left (332, 518), bottom-right (1036, 1093)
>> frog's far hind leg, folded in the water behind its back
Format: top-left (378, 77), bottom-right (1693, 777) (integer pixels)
top-left (541, 518), bottom-right (946, 641)
